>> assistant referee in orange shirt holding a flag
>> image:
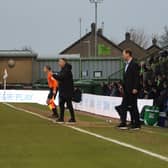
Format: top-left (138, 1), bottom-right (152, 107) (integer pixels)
top-left (44, 65), bottom-right (59, 118)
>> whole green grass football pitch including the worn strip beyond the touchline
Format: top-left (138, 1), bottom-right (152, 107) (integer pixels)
top-left (0, 104), bottom-right (168, 168)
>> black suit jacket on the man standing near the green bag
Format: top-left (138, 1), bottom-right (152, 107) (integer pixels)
top-left (123, 60), bottom-right (140, 94)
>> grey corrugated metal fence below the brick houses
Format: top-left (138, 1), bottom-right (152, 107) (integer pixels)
top-left (36, 57), bottom-right (122, 80)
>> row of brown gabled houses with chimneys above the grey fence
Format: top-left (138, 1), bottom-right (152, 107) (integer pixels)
top-left (60, 23), bottom-right (161, 60)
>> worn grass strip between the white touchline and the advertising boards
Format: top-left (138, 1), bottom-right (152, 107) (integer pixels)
top-left (15, 104), bottom-right (168, 157)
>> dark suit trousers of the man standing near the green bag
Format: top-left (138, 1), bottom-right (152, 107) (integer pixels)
top-left (121, 94), bottom-right (140, 126)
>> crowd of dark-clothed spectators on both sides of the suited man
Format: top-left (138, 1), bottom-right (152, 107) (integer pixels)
top-left (102, 51), bottom-right (168, 111)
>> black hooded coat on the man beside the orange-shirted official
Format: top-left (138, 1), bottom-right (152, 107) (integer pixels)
top-left (53, 63), bottom-right (74, 98)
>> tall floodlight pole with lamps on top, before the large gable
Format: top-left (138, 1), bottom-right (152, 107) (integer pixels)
top-left (90, 0), bottom-right (103, 57)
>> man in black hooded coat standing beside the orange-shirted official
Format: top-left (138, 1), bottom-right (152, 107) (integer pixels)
top-left (53, 58), bottom-right (76, 123)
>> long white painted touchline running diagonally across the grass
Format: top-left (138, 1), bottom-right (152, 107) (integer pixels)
top-left (3, 103), bottom-right (168, 162)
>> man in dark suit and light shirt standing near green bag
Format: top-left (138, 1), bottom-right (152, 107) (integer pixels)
top-left (116, 49), bottom-right (141, 130)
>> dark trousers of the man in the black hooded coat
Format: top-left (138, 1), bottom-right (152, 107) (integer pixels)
top-left (59, 96), bottom-right (75, 120)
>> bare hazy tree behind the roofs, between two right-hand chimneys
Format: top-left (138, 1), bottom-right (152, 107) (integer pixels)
top-left (129, 28), bottom-right (149, 48)
